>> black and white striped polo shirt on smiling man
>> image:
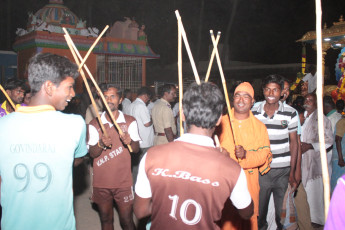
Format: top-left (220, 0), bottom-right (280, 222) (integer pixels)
top-left (252, 101), bottom-right (298, 168)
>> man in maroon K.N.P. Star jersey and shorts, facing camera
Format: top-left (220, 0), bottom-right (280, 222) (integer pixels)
top-left (88, 84), bottom-right (140, 230)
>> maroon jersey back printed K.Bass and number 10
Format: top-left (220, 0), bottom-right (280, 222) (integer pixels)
top-left (136, 134), bottom-right (251, 229)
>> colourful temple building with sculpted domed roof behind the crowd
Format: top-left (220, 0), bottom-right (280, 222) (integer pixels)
top-left (13, 0), bottom-right (159, 93)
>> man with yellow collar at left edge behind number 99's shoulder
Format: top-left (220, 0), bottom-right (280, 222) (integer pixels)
top-left (0, 79), bottom-right (25, 118)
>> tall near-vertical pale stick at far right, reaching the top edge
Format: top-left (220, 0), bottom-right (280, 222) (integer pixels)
top-left (315, 0), bottom-right (330, 220)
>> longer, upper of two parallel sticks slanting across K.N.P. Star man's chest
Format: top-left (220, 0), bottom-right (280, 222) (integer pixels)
top-left (63, 28), bottom-right (133, 152)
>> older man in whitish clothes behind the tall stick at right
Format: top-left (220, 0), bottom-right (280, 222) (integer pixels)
top-left (301, 93), bottom-right (333, 225)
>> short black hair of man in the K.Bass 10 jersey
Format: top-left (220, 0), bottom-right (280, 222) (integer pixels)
top-left (182, 82), bottom-right (224, 129)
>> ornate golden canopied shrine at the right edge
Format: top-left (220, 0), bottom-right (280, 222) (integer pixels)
top-left (297, 15), bottom-right (345, 100)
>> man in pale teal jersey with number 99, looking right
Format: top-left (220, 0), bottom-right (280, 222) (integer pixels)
top-left (0, 53), bottom-right (87, 230)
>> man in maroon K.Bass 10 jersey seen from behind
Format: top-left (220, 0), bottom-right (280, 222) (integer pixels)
top-left (134, 83), bottom-right (253, 230)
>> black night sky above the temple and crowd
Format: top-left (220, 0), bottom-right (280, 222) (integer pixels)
top-left (0, 0), bottom-right (345, 65)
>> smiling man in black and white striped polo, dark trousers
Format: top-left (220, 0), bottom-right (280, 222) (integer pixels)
top-left (252, 75), bottom-right (298, 229)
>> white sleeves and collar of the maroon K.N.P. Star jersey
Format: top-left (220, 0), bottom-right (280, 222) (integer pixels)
top-left (87, 110), bottom-right (141, 147)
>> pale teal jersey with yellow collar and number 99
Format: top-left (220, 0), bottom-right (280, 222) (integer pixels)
top-left (0, 106), bottom-right (87, 230)
